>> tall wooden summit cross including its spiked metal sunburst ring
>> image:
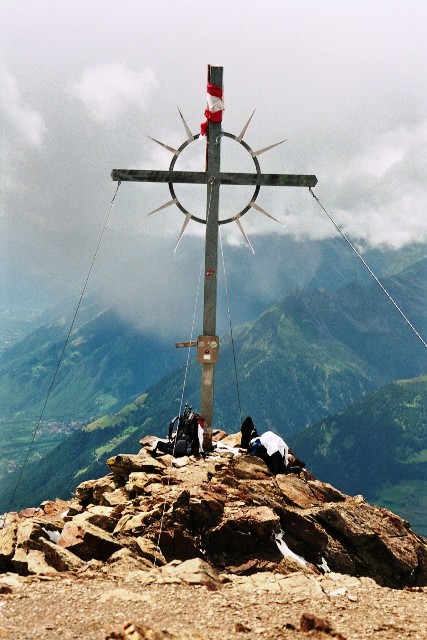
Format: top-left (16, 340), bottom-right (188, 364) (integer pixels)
top-left (111, 65), bottom-right (317, 451)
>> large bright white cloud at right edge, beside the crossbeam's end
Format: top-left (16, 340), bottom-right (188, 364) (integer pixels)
top-left (326, 121), bottom-right (427, 248)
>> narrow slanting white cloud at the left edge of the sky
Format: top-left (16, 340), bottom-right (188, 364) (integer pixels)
top-left (0, 65), bottom-right (46, 147)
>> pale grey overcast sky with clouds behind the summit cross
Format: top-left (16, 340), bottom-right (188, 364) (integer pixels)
top-left (0, 0), bottom-right (427, 336)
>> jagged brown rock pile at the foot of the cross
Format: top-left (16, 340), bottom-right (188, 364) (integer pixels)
top-left (0, 434), bottom-right (427, 588)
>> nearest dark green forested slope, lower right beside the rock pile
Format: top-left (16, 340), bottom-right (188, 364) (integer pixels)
top-left (293, 375), bottom-right (427, 535)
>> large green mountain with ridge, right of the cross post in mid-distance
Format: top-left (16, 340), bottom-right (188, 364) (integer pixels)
top-left (216, 260), bottom-right (427, 434)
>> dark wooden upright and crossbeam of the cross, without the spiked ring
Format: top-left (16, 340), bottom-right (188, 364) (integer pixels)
top-left (111, 65), bottom-right (317, 451)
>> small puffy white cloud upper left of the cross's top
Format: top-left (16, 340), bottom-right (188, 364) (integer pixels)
top-left (70, 62), bottom-right (158, 123)
